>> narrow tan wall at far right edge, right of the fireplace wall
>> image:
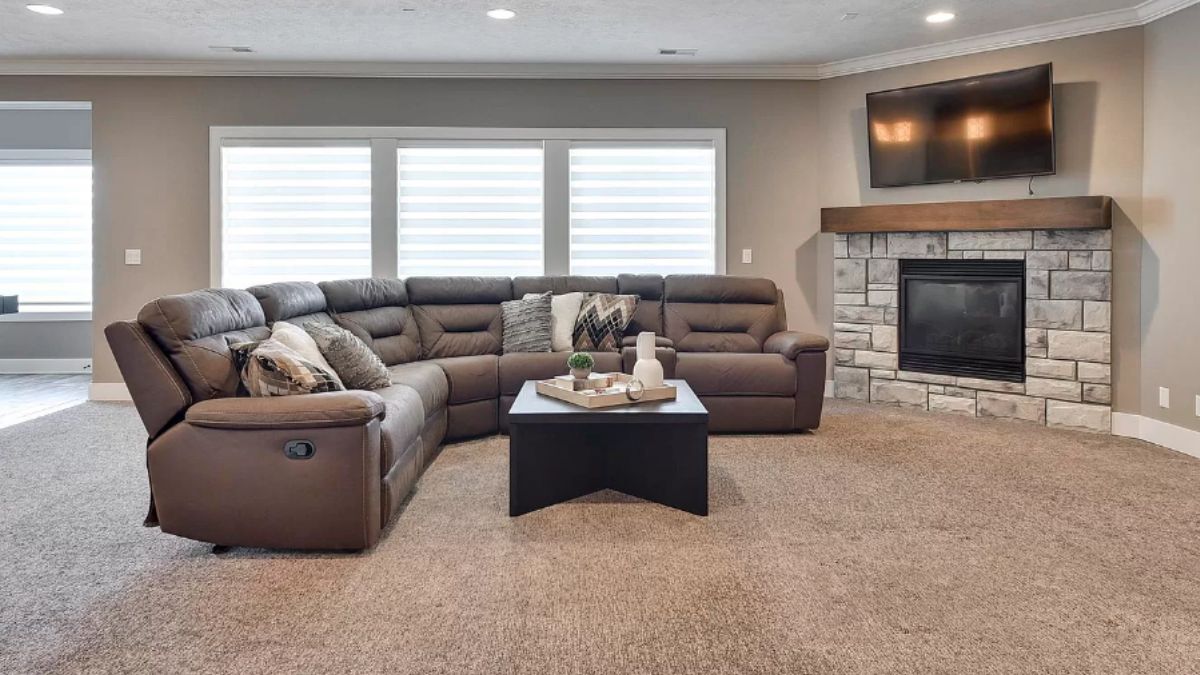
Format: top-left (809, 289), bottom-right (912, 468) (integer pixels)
top-left (1140, 6), bottom-right (1200, 431)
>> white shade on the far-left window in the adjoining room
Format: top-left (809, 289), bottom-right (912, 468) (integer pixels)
top-left (0, 161), bottom-right (91, 311)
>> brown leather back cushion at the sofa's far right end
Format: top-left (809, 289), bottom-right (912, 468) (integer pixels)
top-left (662, 275), bottom-right (787, 352)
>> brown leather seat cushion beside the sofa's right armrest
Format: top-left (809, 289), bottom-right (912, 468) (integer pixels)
top-left (676, 352), bottom-right (796, 396)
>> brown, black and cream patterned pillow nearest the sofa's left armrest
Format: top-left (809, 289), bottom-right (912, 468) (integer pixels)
top-left (229, 338), bottom-right (344, 396)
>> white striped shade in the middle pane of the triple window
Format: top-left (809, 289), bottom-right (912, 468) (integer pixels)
top-left (397, 143), bottom-right (544, 276)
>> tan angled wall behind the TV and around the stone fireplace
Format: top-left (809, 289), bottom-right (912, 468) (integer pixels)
top-left (817, 28), bottom-right (1142, 412)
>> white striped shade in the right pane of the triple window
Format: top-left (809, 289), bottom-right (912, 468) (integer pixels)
top-left (570, 143), bottom-right (716, 275)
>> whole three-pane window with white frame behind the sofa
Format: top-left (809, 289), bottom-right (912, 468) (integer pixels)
top-left (211, 127), bottom-right (725, 282)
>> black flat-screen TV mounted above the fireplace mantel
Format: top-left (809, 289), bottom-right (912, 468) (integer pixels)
top-left (866, 64), bottom-right (1055, 187)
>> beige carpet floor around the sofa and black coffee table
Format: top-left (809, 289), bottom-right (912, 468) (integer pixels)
top-left (0, 402), bottom-right (1200, 674)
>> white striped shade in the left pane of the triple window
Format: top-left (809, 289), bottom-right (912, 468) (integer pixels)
top-left (221, 144), bottom-right (371, 288)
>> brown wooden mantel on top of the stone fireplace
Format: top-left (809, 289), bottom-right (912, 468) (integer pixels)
top-left (821, 197), bottom-right (1112, 232)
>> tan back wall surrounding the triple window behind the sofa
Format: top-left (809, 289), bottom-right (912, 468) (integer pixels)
top-left (0, 77), bottom-right (824, 382)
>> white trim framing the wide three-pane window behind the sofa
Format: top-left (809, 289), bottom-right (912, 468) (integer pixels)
top-left (209, 126), bottom-right (726, 286)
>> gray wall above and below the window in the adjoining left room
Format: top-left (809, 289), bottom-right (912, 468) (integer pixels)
top-left (0, 106), bottom-right (91, 359)
